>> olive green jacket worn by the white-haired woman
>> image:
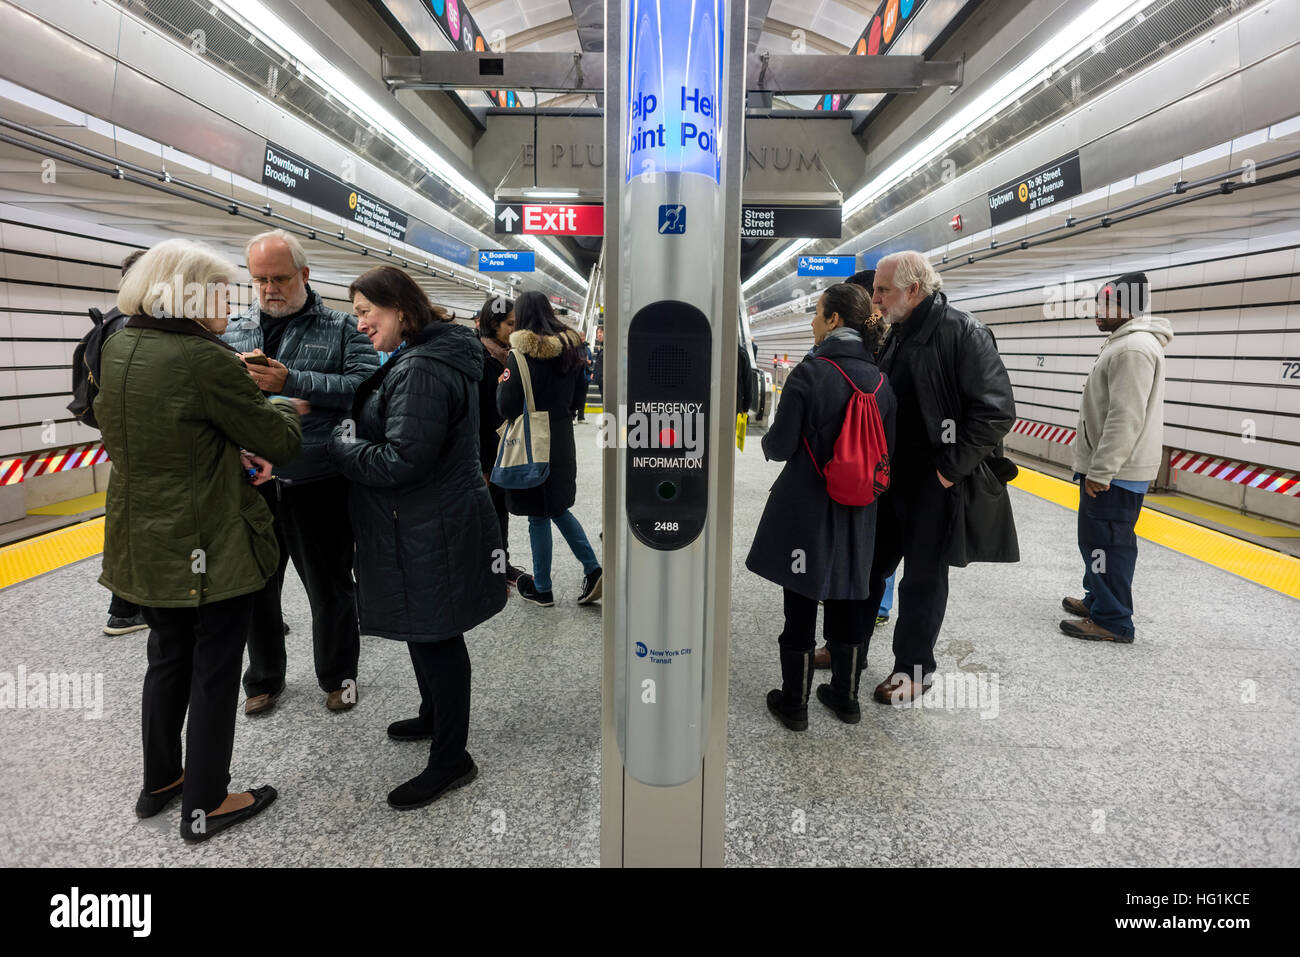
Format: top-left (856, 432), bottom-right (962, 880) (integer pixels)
top-left (95, 316), bottom-right (302, 609)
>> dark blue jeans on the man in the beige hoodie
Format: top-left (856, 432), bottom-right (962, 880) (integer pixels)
top-left (1079, 481), bottom-right (1145, 638)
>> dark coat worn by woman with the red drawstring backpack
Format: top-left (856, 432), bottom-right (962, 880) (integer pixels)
top-left (745, 328), bottom-right (896, 601)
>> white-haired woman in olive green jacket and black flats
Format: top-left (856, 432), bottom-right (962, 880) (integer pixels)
top-left (95, 239), bottom-right (306, 843)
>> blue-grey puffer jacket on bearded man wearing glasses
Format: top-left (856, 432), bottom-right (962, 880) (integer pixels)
top-left (221, 286), bottom-right (380, 482)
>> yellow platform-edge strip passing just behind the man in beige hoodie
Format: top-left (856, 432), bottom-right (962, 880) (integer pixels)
top-left (1011, 465), bottom-right (1300, 598)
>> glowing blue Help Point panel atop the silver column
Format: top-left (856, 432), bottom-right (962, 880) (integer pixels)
top-left (624, 0), bottom-right (723, 182)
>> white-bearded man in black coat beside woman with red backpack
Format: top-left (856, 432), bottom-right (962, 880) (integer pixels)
top-left (863, 252), bottom-right (1019, 705)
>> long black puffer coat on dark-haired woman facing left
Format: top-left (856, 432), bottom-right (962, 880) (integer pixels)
top-left (326, 321), bottom-right (506, 641)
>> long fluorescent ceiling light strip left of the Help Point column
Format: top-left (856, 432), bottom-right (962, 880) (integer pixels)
top-left (216, 0), bottom-right (586, 295)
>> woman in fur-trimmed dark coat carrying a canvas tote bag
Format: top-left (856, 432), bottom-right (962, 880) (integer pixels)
top-left (497, 291), bottom-right (602, 606)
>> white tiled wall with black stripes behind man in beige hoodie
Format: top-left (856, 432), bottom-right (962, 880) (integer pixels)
top-left (977, 247), bottom-right (1300, 469)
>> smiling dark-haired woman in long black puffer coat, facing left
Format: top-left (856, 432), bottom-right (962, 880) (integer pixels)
top-left (328, 265), bottom-right (506, 810)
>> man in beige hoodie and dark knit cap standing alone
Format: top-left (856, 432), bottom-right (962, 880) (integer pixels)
top-left (1061, 273), bottom-right (1174, 644)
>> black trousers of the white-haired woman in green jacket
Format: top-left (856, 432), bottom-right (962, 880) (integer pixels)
top-left (140, 594), bottom-right (252, 822)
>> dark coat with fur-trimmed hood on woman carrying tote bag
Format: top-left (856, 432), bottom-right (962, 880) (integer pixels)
top-left (497, 323), bottom-right (582, 518)
